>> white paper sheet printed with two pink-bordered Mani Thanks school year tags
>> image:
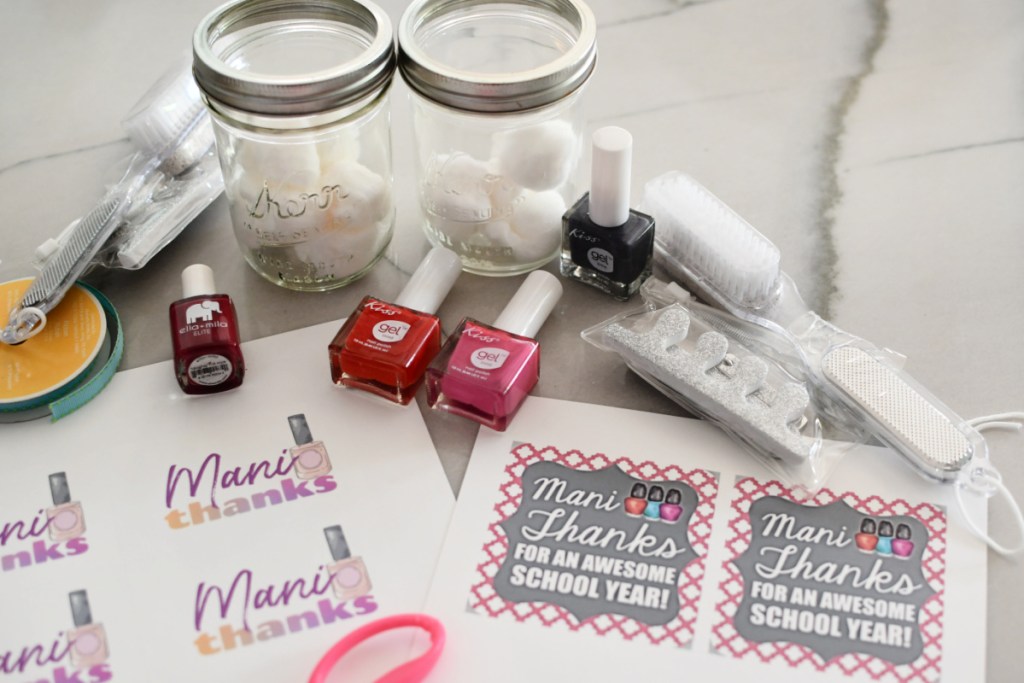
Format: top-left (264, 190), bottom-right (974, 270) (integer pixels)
top-left (427, 397), bottom-right (986, 683)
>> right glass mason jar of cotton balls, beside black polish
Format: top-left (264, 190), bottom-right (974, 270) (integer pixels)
top-left (398, 0), bottom-right (597, 275)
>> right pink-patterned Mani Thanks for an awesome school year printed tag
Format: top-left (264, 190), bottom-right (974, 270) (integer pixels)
top-left (712, 477), bottom-right (947, 681)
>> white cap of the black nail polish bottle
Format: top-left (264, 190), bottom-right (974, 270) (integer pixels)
top-left (589, 126), bottom-right (633, 227)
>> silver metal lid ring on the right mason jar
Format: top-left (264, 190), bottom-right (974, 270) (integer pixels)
top-left (398, 0), bottom-right (597, 113)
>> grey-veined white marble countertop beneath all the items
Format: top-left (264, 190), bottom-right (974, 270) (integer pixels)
top-left (0, 0), bottom-right (1024, 681)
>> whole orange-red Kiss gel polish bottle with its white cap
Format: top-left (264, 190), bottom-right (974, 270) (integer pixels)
top-left (328, 247), bottom-right (462, 405)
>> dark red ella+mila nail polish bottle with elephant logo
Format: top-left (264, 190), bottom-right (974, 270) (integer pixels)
top-left (170, 263), bottom-right (246, 394)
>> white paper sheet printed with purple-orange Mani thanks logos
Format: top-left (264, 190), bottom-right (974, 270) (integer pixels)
top-left (0, 323), bottom-right (454, 683)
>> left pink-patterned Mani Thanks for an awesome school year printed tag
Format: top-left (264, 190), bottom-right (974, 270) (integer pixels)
top-left (469, 443), bottom-right (718, 646)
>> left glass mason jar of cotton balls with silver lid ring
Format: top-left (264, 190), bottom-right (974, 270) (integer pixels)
top-left (193, 0), bottom-right (395, 291)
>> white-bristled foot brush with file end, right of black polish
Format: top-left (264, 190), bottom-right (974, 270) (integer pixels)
top-left (641, 171), bottom-right (986, 480)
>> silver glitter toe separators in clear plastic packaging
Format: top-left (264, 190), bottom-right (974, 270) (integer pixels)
top-left (582, 278), bottom-right (866, 496)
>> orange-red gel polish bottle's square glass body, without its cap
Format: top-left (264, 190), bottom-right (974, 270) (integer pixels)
top-left (329, 297), bottom-right (441, 404)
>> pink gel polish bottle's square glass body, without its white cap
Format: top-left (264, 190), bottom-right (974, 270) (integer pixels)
top-left (427, 318), bottom-right (541, 431)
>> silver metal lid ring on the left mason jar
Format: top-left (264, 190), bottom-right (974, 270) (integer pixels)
top-left (193, 0), bottom-right (395, 116)
